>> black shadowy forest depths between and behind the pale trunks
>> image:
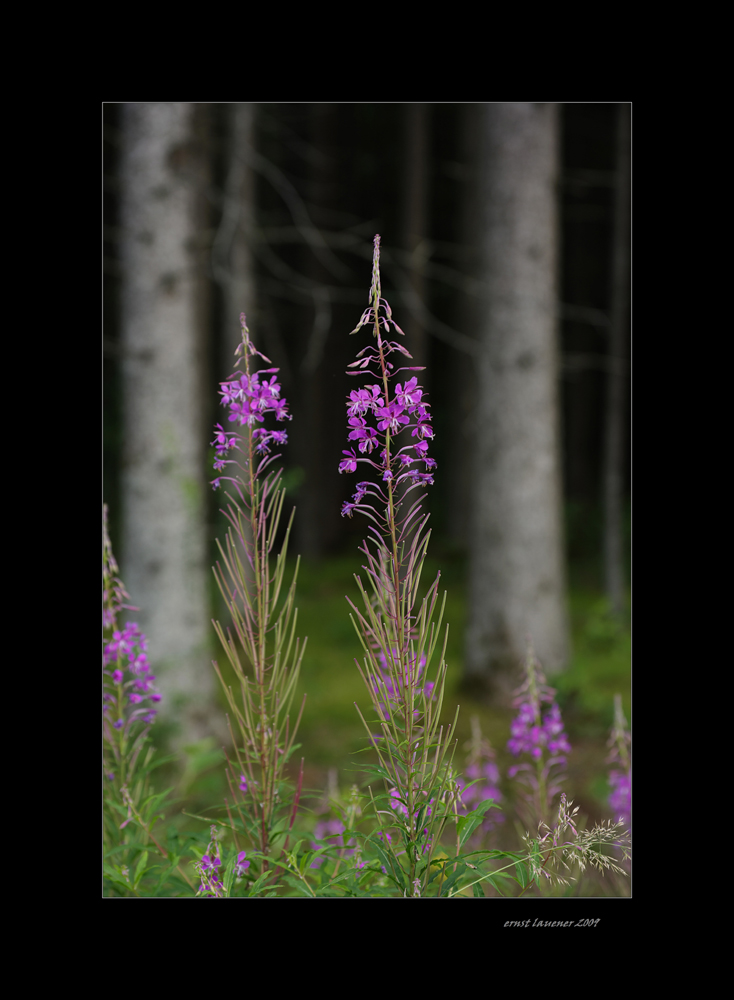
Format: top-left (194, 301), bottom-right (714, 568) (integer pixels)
top-left (103, 103), bottom-right (630, 756)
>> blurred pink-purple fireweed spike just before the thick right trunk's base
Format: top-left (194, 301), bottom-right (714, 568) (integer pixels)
top-left (507, 643), bottom-right (571, 823)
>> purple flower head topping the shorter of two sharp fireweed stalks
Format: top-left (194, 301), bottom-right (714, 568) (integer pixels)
top-left (211, 313), bottom-right (291, 489)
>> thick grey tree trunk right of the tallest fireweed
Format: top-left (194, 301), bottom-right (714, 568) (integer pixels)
top-left (465, 103), bottom-right (568, 695)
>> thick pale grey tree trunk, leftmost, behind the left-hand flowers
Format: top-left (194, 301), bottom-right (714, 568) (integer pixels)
top-left (120, 103), bottom-right (221, 745)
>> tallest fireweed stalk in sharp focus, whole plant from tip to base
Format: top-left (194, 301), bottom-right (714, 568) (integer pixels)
top-left (339, 236), bottom-right (458, 897)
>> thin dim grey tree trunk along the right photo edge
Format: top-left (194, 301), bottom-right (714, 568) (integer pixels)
top-left (604, 104), bottom-right (631, 617)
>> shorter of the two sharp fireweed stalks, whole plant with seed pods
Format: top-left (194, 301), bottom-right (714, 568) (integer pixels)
top-left (212, 313), bottom-right (306, 874)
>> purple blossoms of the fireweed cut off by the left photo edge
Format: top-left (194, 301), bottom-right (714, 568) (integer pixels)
top-left (102, 622), bottom-right (161, 729)
